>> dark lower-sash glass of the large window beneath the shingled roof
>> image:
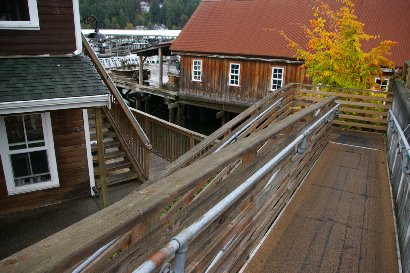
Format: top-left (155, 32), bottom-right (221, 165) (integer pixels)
top-left (10, 151), bottom-right (51, 187)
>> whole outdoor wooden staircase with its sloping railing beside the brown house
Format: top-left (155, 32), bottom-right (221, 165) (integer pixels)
top-left (82, 35), bottom-right (152, 191)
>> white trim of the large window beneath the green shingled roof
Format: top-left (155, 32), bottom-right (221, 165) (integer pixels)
top-left (0, 112), bottom-right (60, 195)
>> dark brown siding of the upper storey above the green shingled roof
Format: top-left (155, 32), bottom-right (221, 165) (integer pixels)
top-left (0, 0), bottom-right (76, 56)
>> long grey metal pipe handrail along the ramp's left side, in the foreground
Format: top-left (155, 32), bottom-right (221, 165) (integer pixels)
top-left (132, 103), bottom-right (340, 273)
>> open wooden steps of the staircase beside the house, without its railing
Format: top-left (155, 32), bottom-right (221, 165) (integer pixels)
top-left (88, 109), bottom-right (138, 186)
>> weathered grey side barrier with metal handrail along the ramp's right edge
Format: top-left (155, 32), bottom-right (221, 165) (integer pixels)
top-left (387, 110), bottom-right (410, 272)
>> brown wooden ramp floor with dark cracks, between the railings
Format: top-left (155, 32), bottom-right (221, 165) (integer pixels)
top-left (244, 129), bottom-right (398, 273)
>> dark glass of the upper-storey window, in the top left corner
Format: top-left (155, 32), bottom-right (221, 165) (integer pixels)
top-left (0, 0), bottom-right (30, 21)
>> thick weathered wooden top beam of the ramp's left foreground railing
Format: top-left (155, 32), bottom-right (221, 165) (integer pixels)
top-left (0, 97), bottom-right (334, 273)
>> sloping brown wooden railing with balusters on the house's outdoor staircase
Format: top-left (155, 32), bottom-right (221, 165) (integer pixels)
top-left (82, 36), bottom-right (152, 181)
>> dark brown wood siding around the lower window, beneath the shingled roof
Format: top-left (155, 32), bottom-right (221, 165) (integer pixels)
top-left (0, 109), bottom-right (90, 214)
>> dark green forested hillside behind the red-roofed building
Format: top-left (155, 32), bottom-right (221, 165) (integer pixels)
top-left (80, 0), bottom-right (200, 29)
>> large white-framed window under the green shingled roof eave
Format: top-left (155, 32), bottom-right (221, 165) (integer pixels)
top-left (0, 113), bottom-right (59, 195)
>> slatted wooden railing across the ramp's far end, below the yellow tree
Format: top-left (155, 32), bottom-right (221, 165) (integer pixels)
top-left (294, 84), bottom-right (393, 132)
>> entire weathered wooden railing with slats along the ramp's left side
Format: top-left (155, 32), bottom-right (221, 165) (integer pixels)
top-left (0, 94), bottom-right (334, 272)
